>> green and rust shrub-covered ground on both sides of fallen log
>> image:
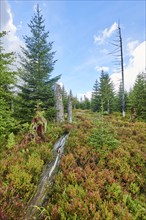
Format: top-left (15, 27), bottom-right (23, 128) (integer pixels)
top-left (0, 110), bottom-right (146, 220)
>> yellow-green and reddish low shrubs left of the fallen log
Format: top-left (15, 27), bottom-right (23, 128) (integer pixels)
top-left (0, 123), bottom-right (69, 220)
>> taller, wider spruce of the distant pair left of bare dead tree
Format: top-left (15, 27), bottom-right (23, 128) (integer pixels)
top-left (99, 70), bottom-right (114, 113)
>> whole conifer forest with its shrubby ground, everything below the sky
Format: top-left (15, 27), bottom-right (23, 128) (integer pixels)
top-left (0, 5), bottom-right (146, 220)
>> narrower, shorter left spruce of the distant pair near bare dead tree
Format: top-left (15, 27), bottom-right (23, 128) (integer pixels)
top-left (91, 79), bottom-right (100, 112)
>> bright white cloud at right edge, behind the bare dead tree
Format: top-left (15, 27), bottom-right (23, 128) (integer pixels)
top-left (111, 41), bottom-right (146, 91)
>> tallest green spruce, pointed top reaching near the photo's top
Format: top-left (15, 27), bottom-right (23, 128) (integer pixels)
top-left (16, 5), bottom-right (60, 121)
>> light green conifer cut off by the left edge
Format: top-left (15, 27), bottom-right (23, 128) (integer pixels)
top-left (0, 31), bottom-right (17, 139)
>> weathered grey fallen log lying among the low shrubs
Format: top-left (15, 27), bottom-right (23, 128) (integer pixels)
top-left (25, 134), bottom-right (69, 220)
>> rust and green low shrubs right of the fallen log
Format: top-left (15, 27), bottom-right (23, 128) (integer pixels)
top-left (42, 111), bottom-right (146, 220)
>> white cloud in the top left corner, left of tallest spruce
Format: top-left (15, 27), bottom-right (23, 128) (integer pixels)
top-left (0, 0), bottom-right (24, 53)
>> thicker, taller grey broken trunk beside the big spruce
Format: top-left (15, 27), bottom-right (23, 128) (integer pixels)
top-left (54, 84), bottom-right (64, 122)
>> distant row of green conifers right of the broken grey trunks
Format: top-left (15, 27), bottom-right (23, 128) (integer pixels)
top-left (76, 70), bottom-right (146, 121)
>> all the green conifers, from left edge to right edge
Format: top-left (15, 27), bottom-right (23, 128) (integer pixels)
top-left (0, 3), bottom-right (146, 146)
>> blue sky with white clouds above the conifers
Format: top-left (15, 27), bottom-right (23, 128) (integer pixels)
top-left (1, 0), bottom-right (146, 96)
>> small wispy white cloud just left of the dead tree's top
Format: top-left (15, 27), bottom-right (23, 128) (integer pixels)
top-left (94, 22), bottom-right (118, 44)
